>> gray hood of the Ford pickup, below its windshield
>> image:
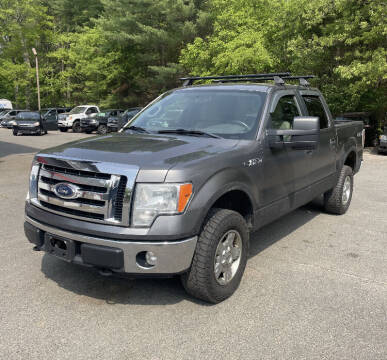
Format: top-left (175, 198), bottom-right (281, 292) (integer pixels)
top-left (38, 133), bottom-right (239, 170)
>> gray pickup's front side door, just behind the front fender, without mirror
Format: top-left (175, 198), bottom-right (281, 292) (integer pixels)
top-left (261, 90), bottom-right (310, 208)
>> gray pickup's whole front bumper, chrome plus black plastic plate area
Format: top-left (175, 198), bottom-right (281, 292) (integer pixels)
top-left (24, 216), bottom-right (197, 275)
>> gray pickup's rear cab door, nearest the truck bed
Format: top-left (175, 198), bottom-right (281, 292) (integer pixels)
top-left (300, 90), bottom-right (337, 184)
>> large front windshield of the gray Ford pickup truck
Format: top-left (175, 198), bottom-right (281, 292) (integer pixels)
top-left (126, 89), bottom-right (266, 139)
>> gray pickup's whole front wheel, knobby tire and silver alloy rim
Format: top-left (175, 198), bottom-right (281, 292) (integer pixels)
top-left (181, 209), bottom-right (249, 304)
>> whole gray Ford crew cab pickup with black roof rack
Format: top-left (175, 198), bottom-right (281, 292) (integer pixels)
top-left (24, 73), bottom-right (363, 303)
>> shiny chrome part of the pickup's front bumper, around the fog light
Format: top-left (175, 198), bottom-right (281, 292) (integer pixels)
top-left (25, 216), bottom-right (197, 274)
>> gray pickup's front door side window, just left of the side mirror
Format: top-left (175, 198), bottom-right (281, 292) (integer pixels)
top-left (271, 95), bottom-right (300, 130)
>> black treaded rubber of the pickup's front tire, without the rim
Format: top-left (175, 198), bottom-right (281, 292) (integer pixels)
top-left (181, 209), bottom-right (249, 304)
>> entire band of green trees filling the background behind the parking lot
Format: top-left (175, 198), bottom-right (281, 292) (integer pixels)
top-left (0, 0), bottom-right (387, 125)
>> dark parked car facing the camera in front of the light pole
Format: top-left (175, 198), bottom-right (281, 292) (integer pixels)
top-left (12, 111), bottom-right (48, 136)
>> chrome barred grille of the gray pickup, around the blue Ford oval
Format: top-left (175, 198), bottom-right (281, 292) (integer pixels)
top-left (35, 164), bottom-right (130, 225)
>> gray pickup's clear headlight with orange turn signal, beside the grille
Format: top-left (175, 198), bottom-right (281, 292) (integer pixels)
top-left (132, 184), bottom-right (192, 227)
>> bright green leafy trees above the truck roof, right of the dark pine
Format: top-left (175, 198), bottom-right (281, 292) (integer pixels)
top-left (180, 0), bottom-right (387, 118)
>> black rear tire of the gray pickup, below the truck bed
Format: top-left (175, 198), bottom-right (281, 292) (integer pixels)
top-left (324, 165), bottom-right (353, 215)
